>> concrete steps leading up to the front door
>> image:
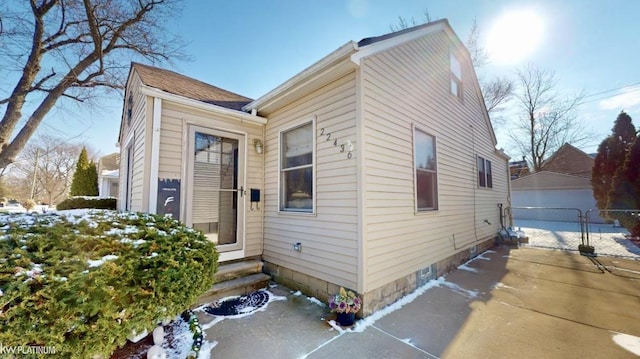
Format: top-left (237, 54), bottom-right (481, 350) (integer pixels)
top-left (195, 260), bottom-right (271, 306)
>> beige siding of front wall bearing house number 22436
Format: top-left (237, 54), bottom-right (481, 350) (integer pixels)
top-left (263, 72), bottom-right (358, 288)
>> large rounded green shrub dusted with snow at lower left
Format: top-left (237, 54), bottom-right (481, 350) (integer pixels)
top-left (0, 211), bottom-right (218, 358)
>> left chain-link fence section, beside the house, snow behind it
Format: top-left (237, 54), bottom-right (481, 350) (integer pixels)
top-left (503, 207), bottom-right (584, 251)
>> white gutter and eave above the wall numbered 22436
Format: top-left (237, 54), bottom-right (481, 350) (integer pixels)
top-left (242, 41), bottom-right (358, 112)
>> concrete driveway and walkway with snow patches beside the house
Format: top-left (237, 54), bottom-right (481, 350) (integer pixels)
top-left (199, 245), bottom-right (640, 359)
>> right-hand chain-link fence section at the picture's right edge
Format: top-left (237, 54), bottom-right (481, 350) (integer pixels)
top-left (585, 209), bottom-right (640, 259)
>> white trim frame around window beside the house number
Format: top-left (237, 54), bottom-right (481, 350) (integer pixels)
top-left (278, 115), bottom-right (318, 216)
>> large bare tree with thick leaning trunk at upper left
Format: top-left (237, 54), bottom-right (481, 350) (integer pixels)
top-left (0, 0), bottom-right (183, 168)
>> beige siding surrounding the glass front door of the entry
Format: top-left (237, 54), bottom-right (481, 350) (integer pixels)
top-left (158, 100), bottom-right (264, 257)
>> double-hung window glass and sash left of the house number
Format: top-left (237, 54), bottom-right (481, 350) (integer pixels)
top-left (280, 122), bottom-right (313, 212)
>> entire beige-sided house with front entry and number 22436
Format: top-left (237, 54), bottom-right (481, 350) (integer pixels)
top-left (120, 20), bottom-right (510, 316)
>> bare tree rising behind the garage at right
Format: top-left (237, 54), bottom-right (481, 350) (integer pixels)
top-left (511, 65), bottom-right (593, 171)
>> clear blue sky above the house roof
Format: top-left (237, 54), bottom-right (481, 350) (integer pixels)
top-left (38, 0), bottom-right (640, 157)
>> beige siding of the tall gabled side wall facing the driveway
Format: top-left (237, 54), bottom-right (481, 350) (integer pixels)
top-left (361, 32), bottom-right (508, 291)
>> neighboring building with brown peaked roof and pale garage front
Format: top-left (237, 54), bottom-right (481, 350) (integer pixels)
top-left (511, 143), bottom-right (601, 221)
